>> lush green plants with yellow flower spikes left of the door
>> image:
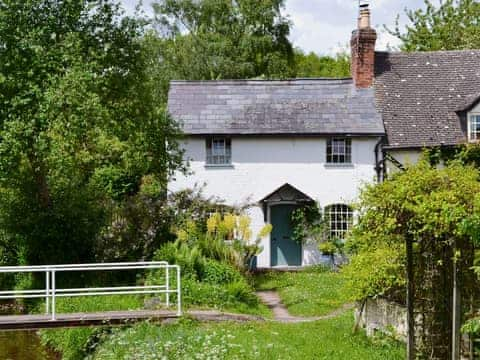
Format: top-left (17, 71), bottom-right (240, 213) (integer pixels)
top-left (149, 213), bottom-right (271, 313)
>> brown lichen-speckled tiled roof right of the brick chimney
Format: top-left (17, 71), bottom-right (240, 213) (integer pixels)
top-left (375, 50), bottom-right (480, 148)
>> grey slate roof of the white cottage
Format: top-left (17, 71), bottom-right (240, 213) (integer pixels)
top-left (168, 79), bottom-right (385, 135)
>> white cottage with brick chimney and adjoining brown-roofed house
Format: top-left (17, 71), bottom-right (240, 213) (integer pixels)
top-left (168, 3), bottom-right (480, 267)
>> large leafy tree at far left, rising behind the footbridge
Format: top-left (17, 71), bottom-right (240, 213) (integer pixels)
top-left (0, 0), bottom-right (181, 264)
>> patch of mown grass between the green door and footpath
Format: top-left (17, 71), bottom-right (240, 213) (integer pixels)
top-left (255, 267), bottom-right (348, 316)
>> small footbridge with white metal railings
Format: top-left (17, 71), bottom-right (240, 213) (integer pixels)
top-left (0, 261), bottom-right (182, 330)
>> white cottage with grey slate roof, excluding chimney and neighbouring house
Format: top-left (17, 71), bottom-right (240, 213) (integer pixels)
top-left (169, 79), bottom-right (384, 267)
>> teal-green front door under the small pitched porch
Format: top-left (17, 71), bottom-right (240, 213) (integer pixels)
top-left (270, 205), bottom-right (302, 266)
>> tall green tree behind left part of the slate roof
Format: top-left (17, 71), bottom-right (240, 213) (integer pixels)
top-left (154, 0), bottom-right (294, 80)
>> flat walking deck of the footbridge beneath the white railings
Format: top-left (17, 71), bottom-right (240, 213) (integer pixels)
top-left (0, 310), bottom-right (178, 330)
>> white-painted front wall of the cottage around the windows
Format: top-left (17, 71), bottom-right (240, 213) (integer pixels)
top-left (169, 137), bottom-right (378, 267)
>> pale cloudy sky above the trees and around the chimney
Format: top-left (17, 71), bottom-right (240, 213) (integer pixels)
top-left (121, 0), bottom-right (432, 55)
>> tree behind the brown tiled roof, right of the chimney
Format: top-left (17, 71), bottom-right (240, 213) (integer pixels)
top-left (387, 0), bottom-right (480, 51)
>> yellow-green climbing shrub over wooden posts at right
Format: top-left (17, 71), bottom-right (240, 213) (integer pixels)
top-left (348, 161), bottom-right (480, 359)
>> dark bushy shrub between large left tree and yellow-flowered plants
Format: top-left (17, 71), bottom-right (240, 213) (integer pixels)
top-left (95, 187), bottom-right (228, 262)
